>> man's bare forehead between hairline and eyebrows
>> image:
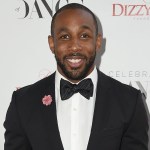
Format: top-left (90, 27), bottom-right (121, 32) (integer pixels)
top-left (54, 8), bottom-right (95, 30)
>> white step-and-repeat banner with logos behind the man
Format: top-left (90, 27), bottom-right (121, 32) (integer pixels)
top-left (0, 0), bottom-right (150, 150)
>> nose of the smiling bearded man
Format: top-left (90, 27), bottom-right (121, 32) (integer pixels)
top-left (69, 38), bottom-right (81, 52)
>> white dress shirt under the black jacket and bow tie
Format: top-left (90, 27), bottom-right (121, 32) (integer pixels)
top-left (55, 67), bottom-right (98, 150)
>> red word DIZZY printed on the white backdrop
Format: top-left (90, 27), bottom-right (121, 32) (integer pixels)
top-left (112, 4), bottom-right (150, 16)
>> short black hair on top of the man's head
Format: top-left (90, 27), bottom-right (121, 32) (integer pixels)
top-left (51, 3), bottom-right (98, 36)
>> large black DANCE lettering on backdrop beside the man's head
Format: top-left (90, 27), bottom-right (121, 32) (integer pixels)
top-left (15, 0), bottom-right (83, 19)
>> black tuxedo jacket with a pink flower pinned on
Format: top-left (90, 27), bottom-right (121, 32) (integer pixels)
top-left (4, 71), bottom-right (148, 150)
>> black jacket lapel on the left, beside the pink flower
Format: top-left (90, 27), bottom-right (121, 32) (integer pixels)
top-left (42, 74), bottom-right (63, 150)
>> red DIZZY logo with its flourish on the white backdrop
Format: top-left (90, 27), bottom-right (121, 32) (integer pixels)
top-left (112, 0), bottom-right (150, 18)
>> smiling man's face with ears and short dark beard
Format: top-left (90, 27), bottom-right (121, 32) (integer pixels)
top-left (49, 9), bottom-right (101, 82)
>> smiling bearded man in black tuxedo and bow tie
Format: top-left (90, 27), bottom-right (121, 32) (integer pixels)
top-left (4, 3), bottom-right (148, 150)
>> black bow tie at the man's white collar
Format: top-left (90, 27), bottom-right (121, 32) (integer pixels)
top-left (60, 79), bottom-right (93, 100)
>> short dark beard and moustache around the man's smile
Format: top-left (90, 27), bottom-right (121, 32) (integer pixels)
top-left (55, 52), bottom-right (96, 80)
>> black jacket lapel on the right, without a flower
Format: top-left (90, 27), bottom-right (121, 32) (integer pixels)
top-left (87, 71), bottom-right (110, 150)
